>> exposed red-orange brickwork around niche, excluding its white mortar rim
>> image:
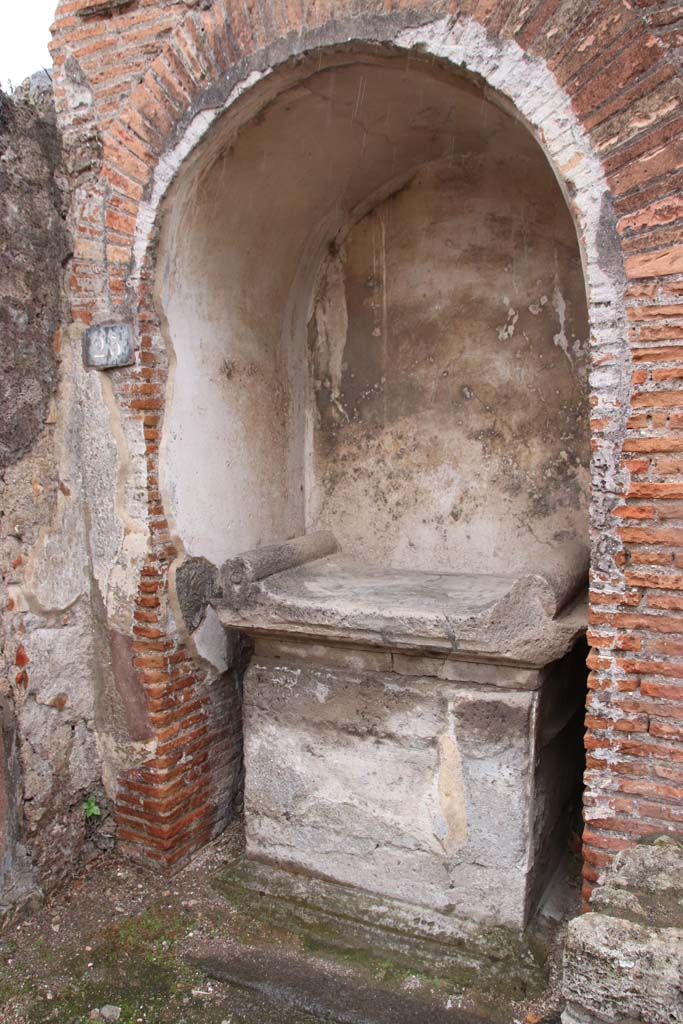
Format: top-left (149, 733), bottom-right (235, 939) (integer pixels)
top-left (52, 0), bottom-right (683, 898)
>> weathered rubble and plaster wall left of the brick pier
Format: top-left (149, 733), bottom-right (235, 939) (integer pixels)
top-left (0, 90), bottom-right (147, 906)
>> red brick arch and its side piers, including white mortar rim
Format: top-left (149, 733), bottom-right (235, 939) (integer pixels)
top-left (54, 0), bottom-right (683, 895)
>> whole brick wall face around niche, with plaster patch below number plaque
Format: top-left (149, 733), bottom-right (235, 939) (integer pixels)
top-left (34, 0), bottom-right (683, 897)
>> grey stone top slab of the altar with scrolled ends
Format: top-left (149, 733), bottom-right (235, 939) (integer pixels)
top-left (215, 554), bottom-right (586, 667)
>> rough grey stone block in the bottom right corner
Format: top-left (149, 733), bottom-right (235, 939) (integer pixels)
top-left (562, 837), bottom-right (683, 1024)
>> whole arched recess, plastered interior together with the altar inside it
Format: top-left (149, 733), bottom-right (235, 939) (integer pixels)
top-left (160, 46), bottom-right (589, 934)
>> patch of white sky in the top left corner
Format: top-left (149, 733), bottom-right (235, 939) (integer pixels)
top-left (0, 0), bottom-right (57, 92)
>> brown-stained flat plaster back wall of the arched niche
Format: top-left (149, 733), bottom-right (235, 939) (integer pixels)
top-left (309, 146), bottom-right (589, 572)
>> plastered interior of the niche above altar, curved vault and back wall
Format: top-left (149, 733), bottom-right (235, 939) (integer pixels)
top-left (158, 54), bottom-right (589, 585)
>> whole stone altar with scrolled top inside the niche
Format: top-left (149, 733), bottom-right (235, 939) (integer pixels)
top-left (208, 534), bottom-right (585, 929)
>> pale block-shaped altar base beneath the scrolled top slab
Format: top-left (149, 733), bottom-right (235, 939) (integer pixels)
top-left (245, 645), bottom-right (581, 928)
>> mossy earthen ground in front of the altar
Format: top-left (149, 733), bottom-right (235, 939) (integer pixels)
top-left (0, 822), bottom-right (562, 1024)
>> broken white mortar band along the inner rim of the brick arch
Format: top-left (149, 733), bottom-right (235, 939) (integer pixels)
top-left (131, 9), bottom-right (630, 573)
